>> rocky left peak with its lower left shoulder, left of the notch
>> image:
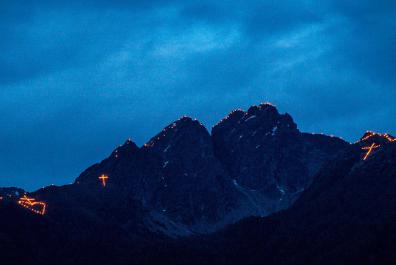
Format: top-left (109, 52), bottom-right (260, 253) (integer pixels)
top-left (75, 117), bottom-right (258, 236)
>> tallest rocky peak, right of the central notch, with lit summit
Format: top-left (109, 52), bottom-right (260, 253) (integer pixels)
top-left (212, 104), bottom-right (348, 214)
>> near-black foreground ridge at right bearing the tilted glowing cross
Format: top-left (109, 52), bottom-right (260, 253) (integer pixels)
top-left (137, 132), bottom-right (396, 265)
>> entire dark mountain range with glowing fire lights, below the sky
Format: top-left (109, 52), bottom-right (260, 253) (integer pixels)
top-left (0, 103), bottom-right (396, 264)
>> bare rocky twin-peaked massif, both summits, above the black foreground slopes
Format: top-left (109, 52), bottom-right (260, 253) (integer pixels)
top-left (70, 104), bottom-right (348, 233)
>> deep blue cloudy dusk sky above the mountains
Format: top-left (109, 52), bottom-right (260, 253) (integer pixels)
top-left (0, 0), bottom-right (396, 190)
